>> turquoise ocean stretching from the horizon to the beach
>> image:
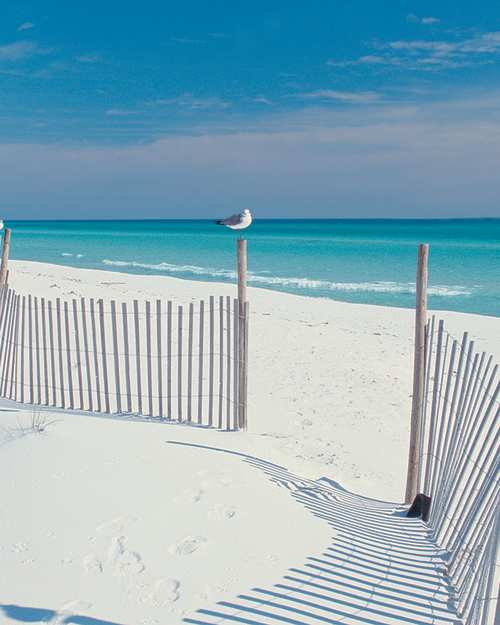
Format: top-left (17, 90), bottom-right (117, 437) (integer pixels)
top-left (7, 219), bottom-right (500, 316)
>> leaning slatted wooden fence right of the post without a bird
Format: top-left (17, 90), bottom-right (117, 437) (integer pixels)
top-left (418, 317), bottom-right (500, 625)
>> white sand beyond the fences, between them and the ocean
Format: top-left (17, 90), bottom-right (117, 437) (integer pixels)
top-left (10, 261), bottom-right (500, 501)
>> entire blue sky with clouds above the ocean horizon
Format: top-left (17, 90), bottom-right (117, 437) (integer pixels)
top-left (0, 0), bottom-right (500, 218)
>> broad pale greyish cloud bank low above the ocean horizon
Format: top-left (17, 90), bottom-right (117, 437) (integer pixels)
top-left (0, 92), bottom-right (500, 218)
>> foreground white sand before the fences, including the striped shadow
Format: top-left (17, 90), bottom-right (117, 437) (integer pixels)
top-left (0, 402), bottom-right (458, 625)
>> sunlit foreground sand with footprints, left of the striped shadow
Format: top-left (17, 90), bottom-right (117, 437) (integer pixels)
top-left (0, 405), bottom-right (332, 625)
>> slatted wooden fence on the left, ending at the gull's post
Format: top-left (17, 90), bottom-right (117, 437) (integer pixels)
top-left (0, 287), bottom-right (249, 430)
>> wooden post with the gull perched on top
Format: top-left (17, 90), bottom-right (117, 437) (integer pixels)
top-left (237, 239), bottom-right (247, 429)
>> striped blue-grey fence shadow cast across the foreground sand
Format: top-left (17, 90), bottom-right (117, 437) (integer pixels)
top-left (169, 441), bottom-right (459, 625)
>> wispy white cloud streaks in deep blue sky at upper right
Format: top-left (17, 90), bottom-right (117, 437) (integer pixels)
top-left (327, 31), bottom-right (500, 71)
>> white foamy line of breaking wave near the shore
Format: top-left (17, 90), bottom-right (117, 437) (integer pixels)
top-left (102, 259), bottom-right (472, 297)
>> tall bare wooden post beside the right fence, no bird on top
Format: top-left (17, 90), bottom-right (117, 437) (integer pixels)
top-left (405, 243), bottom-right (429, 503)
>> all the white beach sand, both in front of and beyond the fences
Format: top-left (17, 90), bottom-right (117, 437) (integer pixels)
top-left (0, 262), bottom-right (500, 625)
